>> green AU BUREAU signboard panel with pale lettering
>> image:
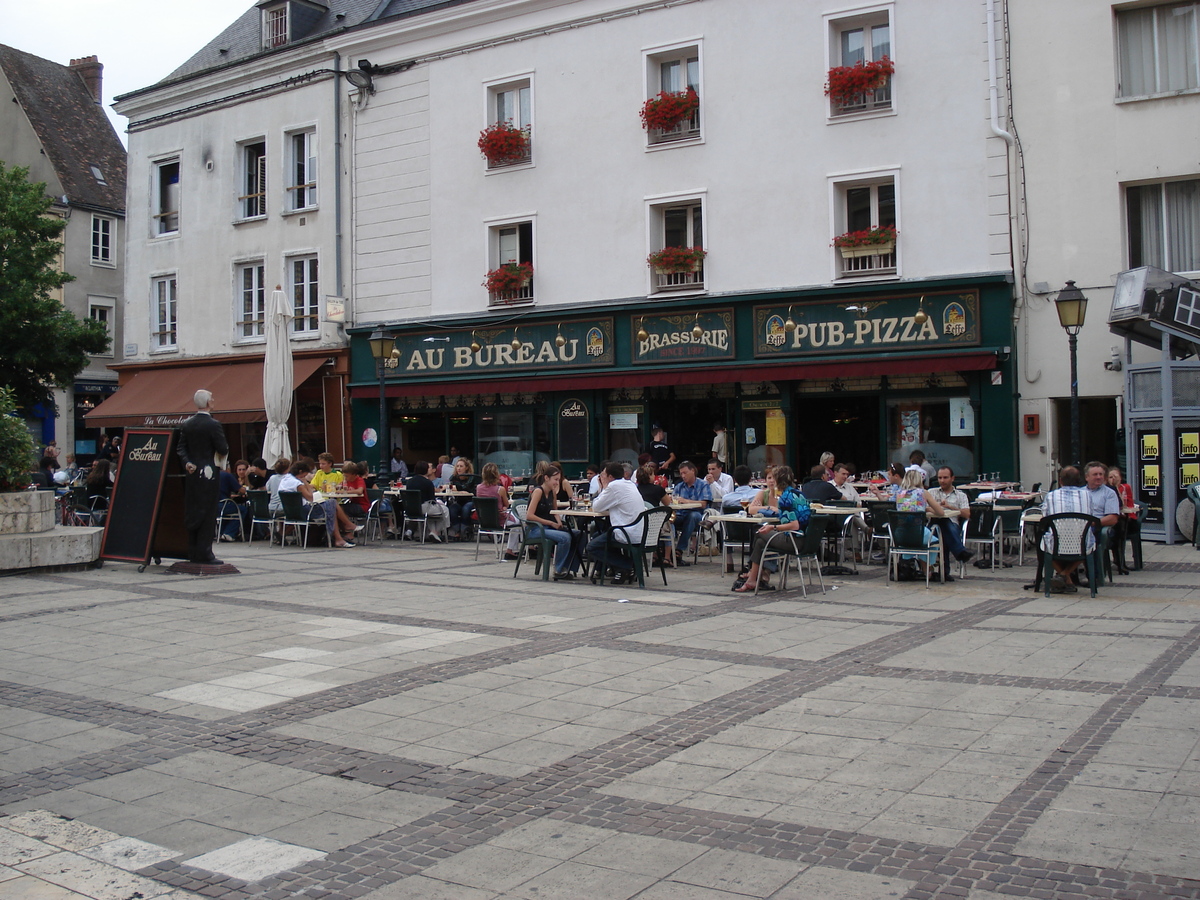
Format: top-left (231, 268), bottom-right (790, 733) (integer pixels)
top-left (391, 318), bottom-right (616, 376)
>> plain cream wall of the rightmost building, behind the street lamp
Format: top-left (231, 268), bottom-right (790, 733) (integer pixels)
top-left (1008, 0), bottom-right (1200, 480)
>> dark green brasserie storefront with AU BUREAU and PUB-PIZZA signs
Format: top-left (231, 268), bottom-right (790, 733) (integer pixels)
top-left (349, 275), bottom-right (1019, 487)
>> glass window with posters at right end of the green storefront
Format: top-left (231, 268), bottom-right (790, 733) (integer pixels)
top-left (887, 396), bottom-right (978, 479)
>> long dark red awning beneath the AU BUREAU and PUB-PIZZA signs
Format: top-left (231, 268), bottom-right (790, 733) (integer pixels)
top-left (345, 350), bottom-right (997, 400)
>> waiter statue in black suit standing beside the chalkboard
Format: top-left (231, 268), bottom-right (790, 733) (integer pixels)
top-left (176, 390), bottom-right (229, 565)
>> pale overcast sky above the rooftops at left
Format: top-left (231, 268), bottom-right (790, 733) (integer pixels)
top-left (0, 0), bottom-right (254, 143)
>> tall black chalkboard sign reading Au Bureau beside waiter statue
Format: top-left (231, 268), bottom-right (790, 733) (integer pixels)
top-left (100, 428), bottom-right (187, 566)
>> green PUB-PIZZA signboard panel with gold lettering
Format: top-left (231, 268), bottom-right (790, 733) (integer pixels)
top-left (754, 290), bottom-right (979, 358)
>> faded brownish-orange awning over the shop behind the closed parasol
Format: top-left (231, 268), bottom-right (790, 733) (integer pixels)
top-left (84, 356), bottom-right (325, 428)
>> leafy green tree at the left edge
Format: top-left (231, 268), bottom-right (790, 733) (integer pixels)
top-left (0, 162), bottom-right (109, 409)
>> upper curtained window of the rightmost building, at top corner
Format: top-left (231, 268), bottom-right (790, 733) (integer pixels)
top-left (1117, 2), bottom-right (1200, 97)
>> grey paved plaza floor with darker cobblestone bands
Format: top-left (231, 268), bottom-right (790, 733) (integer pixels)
top-left (0, 542), bottom-right (1200, 900)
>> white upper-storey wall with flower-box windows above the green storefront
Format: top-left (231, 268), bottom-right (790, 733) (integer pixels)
top-left (344, 0), bottom-right (1010, 322)
